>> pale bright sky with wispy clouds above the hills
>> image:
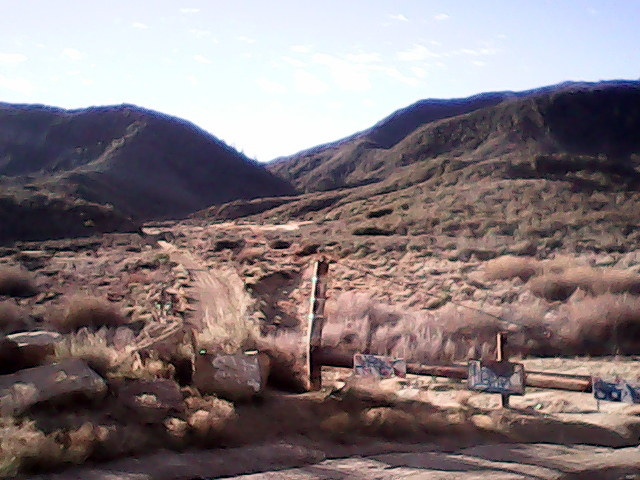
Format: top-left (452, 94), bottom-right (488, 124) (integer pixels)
top-left (0, 0), bottom-right (640, 161)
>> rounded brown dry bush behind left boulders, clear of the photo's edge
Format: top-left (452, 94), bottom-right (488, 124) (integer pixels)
top-left (57, 295), bottom-right (126, 332)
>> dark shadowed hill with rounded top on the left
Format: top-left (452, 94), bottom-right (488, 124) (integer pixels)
top-left (0, 104), bottom-right (293, 239)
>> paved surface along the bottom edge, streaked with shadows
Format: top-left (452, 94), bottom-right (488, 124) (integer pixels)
top-left (36, 443), bottom-right (640, 480)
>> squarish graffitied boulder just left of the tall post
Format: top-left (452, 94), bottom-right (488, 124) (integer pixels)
top-left (193, 353), bottom-right (270, 402)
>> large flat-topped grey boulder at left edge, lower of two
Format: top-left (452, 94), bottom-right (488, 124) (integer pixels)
top-left (0, 359), bottom-right (107, 416)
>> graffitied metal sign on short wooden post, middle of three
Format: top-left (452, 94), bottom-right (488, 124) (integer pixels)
top-left (467, 360), bottom-right (524, 395)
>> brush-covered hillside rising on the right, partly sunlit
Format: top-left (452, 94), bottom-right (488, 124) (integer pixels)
top-left (196, 82), bottom-right (640, 252)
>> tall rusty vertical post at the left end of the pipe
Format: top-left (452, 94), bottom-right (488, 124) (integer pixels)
top-left (307, 260), bottom-right (329, 390)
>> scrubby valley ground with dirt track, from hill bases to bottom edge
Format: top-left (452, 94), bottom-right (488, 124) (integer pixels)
top-left (0, 220), bottom-right (640, 478)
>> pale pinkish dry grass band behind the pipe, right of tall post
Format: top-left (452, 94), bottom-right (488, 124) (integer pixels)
top-left (323, 293), bottom-right (561, 363)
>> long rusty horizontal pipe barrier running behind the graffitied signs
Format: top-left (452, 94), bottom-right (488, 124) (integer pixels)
top-left (312, 347), bottom-right (592, 393)
